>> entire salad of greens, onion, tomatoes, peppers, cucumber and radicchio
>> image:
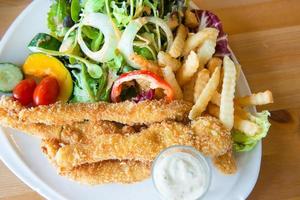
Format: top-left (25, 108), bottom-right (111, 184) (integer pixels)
top-left (0, 0), bottom-right (270, 151)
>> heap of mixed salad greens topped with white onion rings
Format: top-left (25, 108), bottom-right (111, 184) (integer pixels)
top-left (35, 0), bottom-right (192, 102)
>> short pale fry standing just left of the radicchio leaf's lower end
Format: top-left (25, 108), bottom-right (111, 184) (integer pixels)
top-left (197, 38), bottom-right (217, 69)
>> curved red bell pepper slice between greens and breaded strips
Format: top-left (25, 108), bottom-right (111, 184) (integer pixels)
top-left (111, 70), bottom-right (174, 102)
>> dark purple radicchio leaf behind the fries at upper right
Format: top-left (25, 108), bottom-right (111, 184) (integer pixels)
top-left (195, 10), bottom-right (231, 57)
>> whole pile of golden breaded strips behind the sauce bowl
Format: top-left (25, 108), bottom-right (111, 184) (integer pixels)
top-left (0, 94), bottom-right (237, 182)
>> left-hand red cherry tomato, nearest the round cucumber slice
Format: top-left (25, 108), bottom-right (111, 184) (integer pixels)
top-left (13, 79), bottom-right (36, 106)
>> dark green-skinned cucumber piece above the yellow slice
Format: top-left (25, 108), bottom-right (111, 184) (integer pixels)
top-left (28, 33), bottom-right (61, 51)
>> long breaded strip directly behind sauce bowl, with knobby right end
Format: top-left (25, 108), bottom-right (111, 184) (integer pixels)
top-left (55, 117), bottom-right (232, 168)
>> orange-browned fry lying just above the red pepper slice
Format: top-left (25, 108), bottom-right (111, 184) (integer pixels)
top-left (130, 53), bottom-right (161, 75)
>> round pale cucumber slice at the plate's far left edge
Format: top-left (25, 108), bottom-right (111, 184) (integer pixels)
top-left (0, 63), bottom-right (23, 92)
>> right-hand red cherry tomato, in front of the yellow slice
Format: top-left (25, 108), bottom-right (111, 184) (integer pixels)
top-left (33, 76), bottom-right (59, 105)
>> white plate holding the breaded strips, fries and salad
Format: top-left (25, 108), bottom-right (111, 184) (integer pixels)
top-left (0, 0), bottom-right (261, 200)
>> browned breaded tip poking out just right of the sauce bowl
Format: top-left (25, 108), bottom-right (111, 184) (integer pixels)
top-left (213, 151), bottom-right (237, 174)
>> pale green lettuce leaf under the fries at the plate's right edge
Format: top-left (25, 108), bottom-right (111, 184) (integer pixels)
top-left (231, 111), bottom-right (271, 152)
